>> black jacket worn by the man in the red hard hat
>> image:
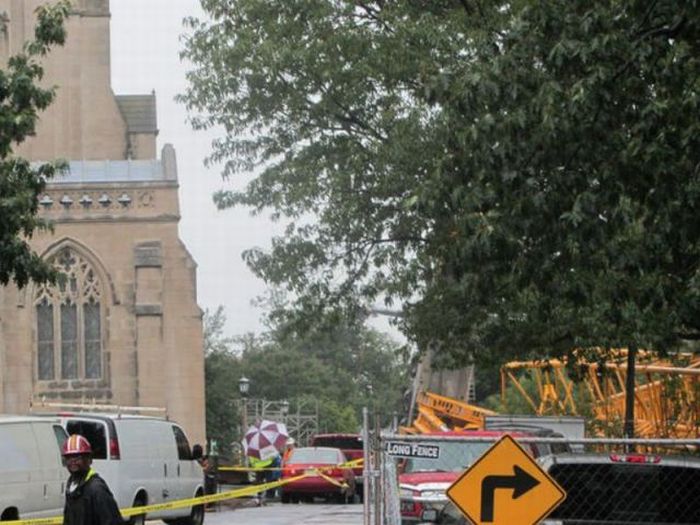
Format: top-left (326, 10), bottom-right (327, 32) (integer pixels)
top-left (63, 469), bottom-right (124, 525)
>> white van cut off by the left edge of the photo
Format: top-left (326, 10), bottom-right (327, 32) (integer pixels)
top-left (0, 415), bottom-right (68, 521)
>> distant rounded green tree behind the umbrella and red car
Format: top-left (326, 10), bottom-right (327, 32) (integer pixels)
top-left (241, 314), bottom-right (410, 432)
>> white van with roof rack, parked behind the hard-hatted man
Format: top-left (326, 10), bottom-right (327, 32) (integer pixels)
top-left (53, 413), bottom-right (204, 525)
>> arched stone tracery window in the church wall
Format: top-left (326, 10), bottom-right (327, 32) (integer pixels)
top-left (34, 247), bottom-right (103, 381)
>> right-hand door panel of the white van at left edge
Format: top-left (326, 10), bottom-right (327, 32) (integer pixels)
top-left (32, 422), bottom-right (68, 516)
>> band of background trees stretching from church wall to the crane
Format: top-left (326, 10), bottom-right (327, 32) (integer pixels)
top-left (204, 307), bottom-right (409, 448)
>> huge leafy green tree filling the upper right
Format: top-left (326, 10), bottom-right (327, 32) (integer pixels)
top-left (181, 0), bottom-right (700, 363)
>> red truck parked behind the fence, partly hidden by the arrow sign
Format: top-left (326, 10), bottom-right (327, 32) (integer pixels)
top-left (399, 429), bottom-right (568, 524)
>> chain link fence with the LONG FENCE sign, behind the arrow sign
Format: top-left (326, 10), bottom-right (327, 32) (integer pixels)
top-left (364, 432), bottom-right (700, 525)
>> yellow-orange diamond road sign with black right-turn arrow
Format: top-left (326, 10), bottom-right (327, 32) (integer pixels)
top-left (447, 435), bottom-right (566, 525)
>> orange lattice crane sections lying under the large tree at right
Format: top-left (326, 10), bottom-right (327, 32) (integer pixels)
top-left (501, 349), bottom-right (700, 438)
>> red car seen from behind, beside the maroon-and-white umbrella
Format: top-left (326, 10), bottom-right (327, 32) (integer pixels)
top-left (281, 447), bottom-right (355, 503)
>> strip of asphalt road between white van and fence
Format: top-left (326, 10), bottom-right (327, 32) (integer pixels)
top-left (197, 502), bottom-right (362, 525)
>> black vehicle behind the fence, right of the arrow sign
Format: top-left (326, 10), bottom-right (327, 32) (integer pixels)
top-left (423, 454), bottom-right (700, 525)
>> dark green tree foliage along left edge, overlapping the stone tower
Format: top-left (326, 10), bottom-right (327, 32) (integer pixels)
top-left (0, 0), bottom-right (70, 287)
